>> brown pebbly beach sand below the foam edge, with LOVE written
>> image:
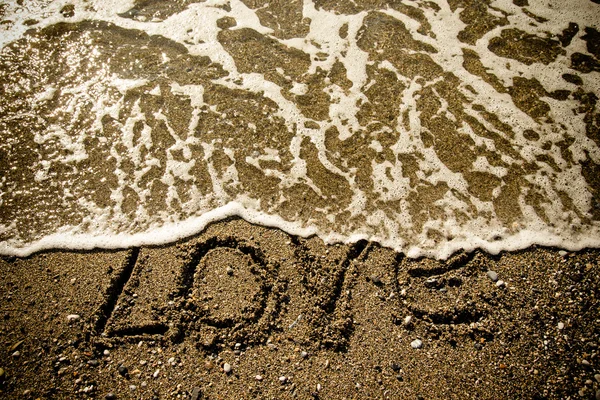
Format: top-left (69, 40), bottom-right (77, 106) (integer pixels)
top-left (0, 219), bottom-right (600, 399)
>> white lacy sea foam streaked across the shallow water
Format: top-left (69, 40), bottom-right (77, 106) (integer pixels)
top-left (0, 0), bottom-right (600, 258)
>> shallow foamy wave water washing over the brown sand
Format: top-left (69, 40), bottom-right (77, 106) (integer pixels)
top-left (0, 0), bottom-right (600, 258)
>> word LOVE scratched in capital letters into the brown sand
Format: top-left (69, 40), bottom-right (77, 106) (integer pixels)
top-left (86, 223), bottom-right (501, 352)
